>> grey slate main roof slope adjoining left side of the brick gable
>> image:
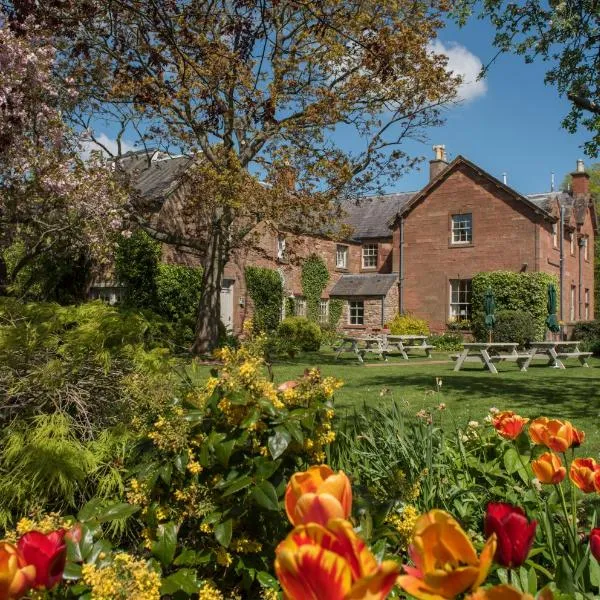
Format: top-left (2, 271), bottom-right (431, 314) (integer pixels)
top-left (341, 192), bottom-right (416, 240)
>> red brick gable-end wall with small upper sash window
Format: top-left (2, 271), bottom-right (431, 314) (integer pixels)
top-left (403, 165), bottom-right (543, 331)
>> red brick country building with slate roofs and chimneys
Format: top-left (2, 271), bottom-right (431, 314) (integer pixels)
top-left (112, 146), bottom-right (596, 332)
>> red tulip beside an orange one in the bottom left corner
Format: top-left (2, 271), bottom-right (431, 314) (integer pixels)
top-left (17, 529), bottom-right (67, 589)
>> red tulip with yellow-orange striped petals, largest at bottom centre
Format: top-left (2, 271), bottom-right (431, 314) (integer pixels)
top-left (275, 519), bottom-right (399, 600)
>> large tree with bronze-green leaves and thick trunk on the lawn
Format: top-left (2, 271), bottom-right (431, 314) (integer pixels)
top-left (8, 0), bottom-right (459, 352)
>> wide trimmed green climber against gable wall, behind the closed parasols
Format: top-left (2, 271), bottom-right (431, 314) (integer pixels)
top-left (471, 271), bottom-right (560, 341)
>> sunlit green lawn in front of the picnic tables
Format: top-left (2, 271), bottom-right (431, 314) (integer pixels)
top-left (197, 351), bottom-right (600, 458)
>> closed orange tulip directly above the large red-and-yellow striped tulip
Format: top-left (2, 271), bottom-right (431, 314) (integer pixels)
top-left (285, 465), bottom-right (352, 525)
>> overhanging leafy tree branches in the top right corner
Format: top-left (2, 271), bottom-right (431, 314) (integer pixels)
top-left (459, 0), bottom-right (600, 157)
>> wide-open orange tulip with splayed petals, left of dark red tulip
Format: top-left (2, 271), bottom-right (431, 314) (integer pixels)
top-left (397, 510), bottom-right (496, 600)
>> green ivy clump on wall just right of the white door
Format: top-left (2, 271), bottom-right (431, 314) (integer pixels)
top-left (245, 267), bottom-right (283, 331)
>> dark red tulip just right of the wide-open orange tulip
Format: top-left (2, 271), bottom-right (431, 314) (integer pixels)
top-left (485, 502), bottom-right (537, 567)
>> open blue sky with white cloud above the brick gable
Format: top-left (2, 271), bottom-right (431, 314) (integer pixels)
top-left (91, 19), bottom-right (591, 194)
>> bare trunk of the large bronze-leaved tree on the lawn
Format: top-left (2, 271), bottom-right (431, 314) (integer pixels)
top-left (192, 225), bottom-right (227, 354)
